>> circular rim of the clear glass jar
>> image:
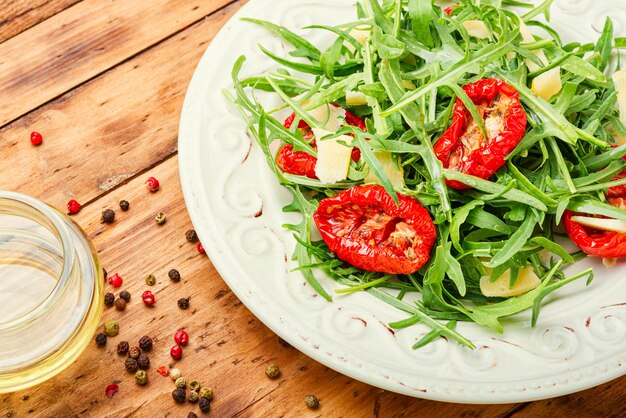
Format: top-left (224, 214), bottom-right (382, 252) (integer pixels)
top-left (0, 190), bottom-right (75, 331)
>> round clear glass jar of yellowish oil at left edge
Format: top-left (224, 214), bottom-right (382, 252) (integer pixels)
top-left (0, 191), bottom-right (104, 393)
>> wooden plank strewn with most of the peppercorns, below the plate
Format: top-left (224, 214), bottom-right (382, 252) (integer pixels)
top-left (0, 157), bottom-right (510, 417)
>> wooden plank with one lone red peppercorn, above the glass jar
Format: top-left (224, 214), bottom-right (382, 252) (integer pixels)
top-left (0, 2), bottom-right (243, 212)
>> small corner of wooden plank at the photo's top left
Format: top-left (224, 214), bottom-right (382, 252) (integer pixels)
top-left (0, 0), bottom-right (81, 43)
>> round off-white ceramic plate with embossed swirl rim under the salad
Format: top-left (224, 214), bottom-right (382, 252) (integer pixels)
top-left (179, 0), bottom-right (626, 403)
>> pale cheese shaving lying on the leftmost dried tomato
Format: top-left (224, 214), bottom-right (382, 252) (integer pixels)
top-left (313, 128), bottom-right (352, 184)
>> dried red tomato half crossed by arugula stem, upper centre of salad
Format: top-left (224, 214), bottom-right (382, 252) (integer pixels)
top-left (435, 78), bottom-right (526, 189)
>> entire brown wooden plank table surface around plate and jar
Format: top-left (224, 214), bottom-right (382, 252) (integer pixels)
top-left (0, 0), bottom-right (626, 417)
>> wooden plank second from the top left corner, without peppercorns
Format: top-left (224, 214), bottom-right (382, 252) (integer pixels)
top-left (0, 0), bottom-right (233, 126)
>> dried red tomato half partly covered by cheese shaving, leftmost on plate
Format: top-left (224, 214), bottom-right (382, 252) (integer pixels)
top-left (276, 104), bottom-right (367, 179)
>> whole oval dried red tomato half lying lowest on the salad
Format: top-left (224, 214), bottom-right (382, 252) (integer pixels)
top-left (313, 185), bottom-right (437, 274)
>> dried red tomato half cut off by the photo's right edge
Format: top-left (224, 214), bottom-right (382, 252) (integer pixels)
top-left (563, 156), bottom-right (626, 258)
